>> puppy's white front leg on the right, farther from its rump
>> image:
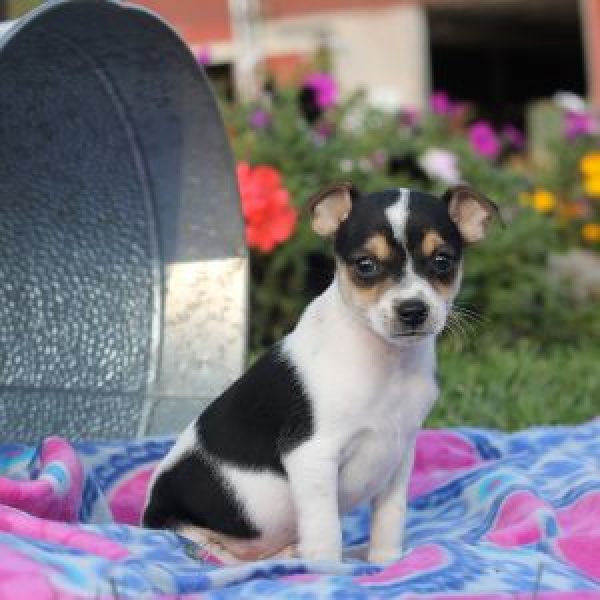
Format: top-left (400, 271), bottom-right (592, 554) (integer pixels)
top-left (368, 438), bottom-right (415, 562)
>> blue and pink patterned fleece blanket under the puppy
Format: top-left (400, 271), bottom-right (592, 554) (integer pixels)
top-left (0, 421), bottom-right (600, 600)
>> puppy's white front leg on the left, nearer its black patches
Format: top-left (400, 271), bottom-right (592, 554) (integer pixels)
top-left (284, 442), bottom-right (342, 561)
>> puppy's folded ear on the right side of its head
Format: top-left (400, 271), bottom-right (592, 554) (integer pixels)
top-left (442, 185), bottom-right (500, 244)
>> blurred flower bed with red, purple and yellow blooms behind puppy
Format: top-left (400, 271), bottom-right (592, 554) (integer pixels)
top-left (224, 78), bottom-right (600, 358)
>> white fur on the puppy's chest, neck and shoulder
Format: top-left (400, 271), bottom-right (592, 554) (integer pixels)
top-left (283, 284), bottom-right (437, 510)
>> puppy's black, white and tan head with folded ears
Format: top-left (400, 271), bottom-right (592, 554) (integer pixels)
top-left (310, 184), bottom-right (497, 346)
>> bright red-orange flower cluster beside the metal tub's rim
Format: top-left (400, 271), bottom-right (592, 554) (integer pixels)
top-left (237, 162), bottom-right (297, 252)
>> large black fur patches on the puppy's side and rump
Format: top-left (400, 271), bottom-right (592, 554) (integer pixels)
top-left (143, 346), bottom-right (314, 539)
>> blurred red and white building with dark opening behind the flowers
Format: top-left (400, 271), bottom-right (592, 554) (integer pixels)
top-left (0, 0), bottom-right (600, 123)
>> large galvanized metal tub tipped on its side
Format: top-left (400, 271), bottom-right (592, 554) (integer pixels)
top-left (0, 0), bottom-right (247, 442)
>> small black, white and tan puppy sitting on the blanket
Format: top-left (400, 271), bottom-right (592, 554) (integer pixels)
top-left (143, 184), bottom-right (496, 563)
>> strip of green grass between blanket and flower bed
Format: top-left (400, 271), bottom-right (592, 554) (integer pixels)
top-left (427, 332), bottom-right (600, 430)
